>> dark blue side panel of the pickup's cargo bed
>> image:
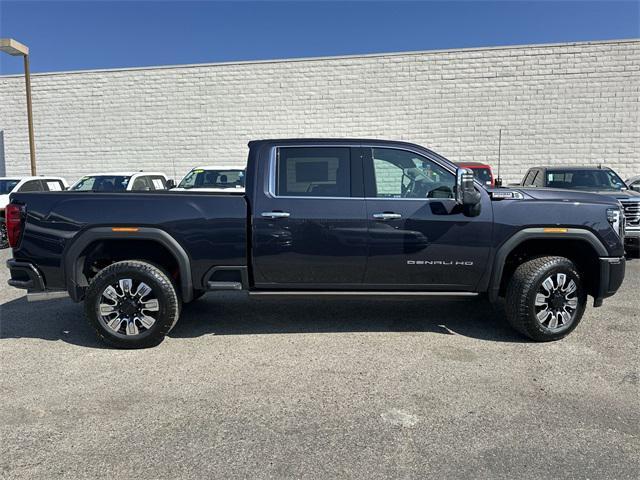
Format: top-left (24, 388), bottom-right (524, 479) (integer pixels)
top-left (12, 192), bottom-right (248, 289)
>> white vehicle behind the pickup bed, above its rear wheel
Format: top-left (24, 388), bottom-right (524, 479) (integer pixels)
top-left (69, 172), bottom-right (174, 192)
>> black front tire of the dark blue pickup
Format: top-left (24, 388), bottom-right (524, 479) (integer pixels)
top-left (505, 257), bottom-right (587, 342)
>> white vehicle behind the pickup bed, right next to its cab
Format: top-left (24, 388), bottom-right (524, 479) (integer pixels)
top-left (173, 165), bottom-right (245, 192)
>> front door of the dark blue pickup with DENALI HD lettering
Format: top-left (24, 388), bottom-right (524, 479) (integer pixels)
top-left (362, 147), bottom-right (493, 291)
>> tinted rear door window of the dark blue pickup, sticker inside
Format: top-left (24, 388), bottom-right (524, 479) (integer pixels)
top-left (276, 147), bottom-right (351, 197)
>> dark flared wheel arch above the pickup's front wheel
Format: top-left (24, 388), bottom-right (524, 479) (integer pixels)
top-left (488, 227), bottom-right (609, 301)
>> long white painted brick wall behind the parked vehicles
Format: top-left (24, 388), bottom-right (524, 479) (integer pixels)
top-left (0, 40), bottom-right (640, 182)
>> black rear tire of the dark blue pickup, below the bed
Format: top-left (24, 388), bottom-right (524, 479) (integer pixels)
top-left (84, 260), bottom-right (180, 348)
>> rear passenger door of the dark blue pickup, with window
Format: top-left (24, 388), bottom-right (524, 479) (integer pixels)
top-left (252, 145), bottom-right (367, 289)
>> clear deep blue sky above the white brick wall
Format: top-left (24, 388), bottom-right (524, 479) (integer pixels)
top-left (0, 0), bottom-right (640, 74)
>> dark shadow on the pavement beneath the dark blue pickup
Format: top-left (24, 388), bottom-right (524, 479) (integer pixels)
top-left (0, 293), bottom-right (527, 348)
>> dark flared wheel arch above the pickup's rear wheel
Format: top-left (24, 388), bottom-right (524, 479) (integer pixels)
top-left (63, 227), bottom-right (193, 302)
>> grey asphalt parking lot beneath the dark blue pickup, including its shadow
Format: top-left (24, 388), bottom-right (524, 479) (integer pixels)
top-left (0, 251), bottom-right (640, 479)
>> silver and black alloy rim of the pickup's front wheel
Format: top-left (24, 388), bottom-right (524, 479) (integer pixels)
top-left (535, 273), bottom-right (578, 331)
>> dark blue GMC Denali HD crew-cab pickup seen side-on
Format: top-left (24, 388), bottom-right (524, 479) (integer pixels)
top-left (7, 139), bottom-right (625, 348)
